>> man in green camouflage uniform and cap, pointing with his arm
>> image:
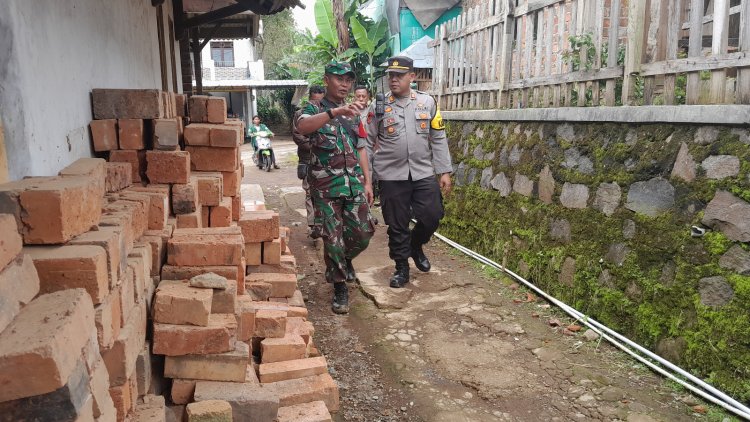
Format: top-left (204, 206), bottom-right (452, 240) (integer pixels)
top-left (297, 61), bottom-right (375, 313)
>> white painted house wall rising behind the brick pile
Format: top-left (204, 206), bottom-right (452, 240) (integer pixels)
top-left (0, 0), bottom-right (180, 180)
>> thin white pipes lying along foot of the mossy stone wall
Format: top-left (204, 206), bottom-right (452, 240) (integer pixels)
top-left (435, 233), bottom-right (750, 420)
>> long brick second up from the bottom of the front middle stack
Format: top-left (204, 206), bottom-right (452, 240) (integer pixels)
top-left (164, 341), bottom-right (250, 382)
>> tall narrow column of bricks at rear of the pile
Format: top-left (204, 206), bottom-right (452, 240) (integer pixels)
top-left (178, 95), bottom-right (245, 227)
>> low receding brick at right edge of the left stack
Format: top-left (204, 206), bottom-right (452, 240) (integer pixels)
top-left (102, 296), bottom-right (148, 386)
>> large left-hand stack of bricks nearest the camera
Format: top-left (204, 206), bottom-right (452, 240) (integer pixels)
top-left (0, 159), bottom-right (167, 421)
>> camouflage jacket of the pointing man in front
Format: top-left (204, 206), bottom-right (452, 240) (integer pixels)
top-left (298, 101), bottom-right (366, 198)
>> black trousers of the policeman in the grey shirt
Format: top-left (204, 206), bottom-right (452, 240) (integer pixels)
top-left (380, 175), bottom-right (444, 261)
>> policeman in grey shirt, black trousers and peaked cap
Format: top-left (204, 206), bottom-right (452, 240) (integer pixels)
top-left (367, 56), bottom-right (452, 288)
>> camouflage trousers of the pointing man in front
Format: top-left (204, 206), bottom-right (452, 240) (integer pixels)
top-left (312, 191), bottom-right (375, 283)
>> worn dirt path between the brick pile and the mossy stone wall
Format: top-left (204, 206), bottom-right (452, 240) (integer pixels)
top-left (250, 138), bottom-right (723, 422)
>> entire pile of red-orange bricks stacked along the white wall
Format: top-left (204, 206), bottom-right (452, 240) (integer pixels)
top-left (0, 90), bottom-right (339, 422)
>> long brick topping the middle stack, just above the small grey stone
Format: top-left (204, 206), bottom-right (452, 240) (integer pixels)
top-left (167, 228), bottom-right (245, 267)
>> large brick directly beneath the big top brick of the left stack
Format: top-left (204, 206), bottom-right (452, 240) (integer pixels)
top-left (24, 245), bottom-right (109, 304)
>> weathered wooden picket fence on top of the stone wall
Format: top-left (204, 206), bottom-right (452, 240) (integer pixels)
top-left (430, 0), bottom-right (750, 110)
